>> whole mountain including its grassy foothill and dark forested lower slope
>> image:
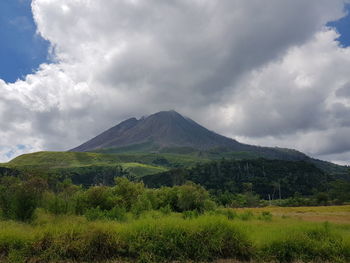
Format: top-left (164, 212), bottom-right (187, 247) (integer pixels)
top-left (0, 111), bottom-right (350, 188)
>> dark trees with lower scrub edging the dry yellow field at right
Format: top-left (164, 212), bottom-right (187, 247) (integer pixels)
top-left (142, 159), bottom-right (350, 206)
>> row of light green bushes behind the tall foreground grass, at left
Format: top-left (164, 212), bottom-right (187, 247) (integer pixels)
top-left (0, 176), bottom-right (216, 221)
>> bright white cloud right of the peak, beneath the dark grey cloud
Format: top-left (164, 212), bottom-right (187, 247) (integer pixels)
top-left (216, 29), bottom-right (350, 161)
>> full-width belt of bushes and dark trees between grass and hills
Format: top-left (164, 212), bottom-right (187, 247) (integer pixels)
top-left (0, 159), bottom-right (350, 221)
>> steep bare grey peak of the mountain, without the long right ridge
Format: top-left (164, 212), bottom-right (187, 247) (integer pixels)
top-left (72, 111), bottom-right (240, 152)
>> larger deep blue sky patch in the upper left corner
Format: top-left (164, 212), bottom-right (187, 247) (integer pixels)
top-left (0, 0), bottom-right (49, 82)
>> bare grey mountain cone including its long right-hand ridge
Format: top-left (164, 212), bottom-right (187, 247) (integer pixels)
top-left (70, 111), bottom-right (308, 160)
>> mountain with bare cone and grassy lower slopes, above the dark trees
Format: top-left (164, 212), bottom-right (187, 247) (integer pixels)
top-left (0, 111), bottom-right (348, 185)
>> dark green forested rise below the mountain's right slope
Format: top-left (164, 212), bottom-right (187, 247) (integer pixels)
top-left (142, 159), bottom-right (335, 199)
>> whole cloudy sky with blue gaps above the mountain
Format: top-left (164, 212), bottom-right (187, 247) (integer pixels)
top-left (0, 0), bottom-right (350, 164)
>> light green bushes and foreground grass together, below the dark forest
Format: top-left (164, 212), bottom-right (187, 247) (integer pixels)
top-left (0, 172), bottom-right (350, 262)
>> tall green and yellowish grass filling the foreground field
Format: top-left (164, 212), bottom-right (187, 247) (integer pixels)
top-left (0, 209), bottom-right (350, 262)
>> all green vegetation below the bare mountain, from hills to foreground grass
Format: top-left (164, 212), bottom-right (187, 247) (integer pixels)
top-left (0, 152), bottom-right (350, 263)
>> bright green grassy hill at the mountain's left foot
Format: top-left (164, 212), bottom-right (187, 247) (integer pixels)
top-left (0, 152), bottom-right (209, 185)
